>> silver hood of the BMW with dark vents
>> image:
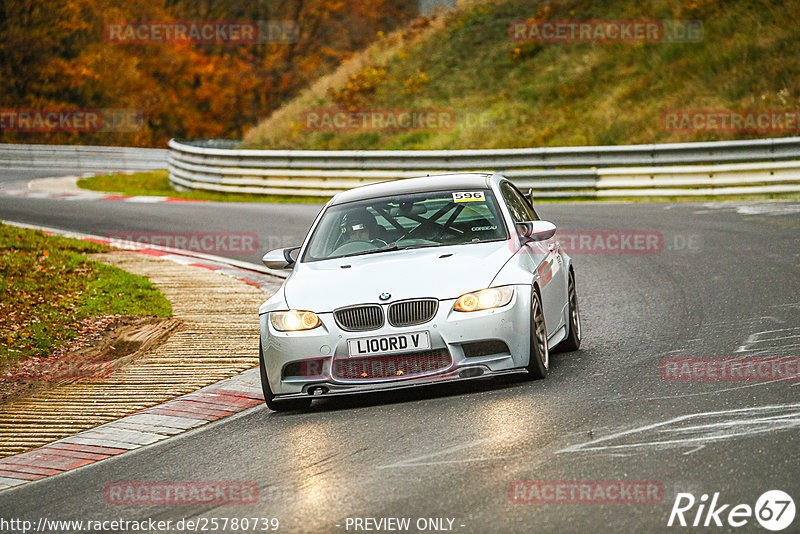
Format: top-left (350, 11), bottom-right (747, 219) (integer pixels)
top-left (284, 241), bottom-right (512, 313)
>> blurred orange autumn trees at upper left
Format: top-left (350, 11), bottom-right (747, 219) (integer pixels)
top-left (0, 0), bottom-right (416, 146)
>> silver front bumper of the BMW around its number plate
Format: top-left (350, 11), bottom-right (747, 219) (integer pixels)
top-left (260, 285), bottom-right (530, 399)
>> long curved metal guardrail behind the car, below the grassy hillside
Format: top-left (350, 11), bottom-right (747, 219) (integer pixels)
top-left (169, 137), bottom-right (800, 197)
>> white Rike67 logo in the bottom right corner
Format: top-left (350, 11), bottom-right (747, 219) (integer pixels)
top-left (667, 490), bottom-right (795, 531)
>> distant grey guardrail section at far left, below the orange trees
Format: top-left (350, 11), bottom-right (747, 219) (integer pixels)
top-left (0, 144), bottom-right (169, 170)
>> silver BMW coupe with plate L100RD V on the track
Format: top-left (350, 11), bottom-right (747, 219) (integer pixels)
top-left (259, 173), bottom-right (581, 410)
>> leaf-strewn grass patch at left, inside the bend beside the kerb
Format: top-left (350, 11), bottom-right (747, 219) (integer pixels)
top-left (0, 224), bottom-right (172, 375)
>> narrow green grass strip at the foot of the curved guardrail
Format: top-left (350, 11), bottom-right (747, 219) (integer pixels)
top-left (78, 170), bottom-right (329, 203)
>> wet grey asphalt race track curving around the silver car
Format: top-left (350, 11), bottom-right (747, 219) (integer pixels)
top-left (0, 170), bottom-right (800, 533)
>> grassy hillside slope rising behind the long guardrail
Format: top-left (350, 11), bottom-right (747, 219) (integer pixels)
top-left (243, 0), bottom-right (800, 149)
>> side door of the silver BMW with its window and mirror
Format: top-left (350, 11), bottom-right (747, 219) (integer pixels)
top-left (500, 182), bottom-right (567, 335)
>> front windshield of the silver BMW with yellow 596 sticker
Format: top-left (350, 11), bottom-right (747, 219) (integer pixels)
top-left (302, 189), bottom-right (508, 261)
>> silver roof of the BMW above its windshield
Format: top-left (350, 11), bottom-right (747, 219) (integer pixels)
top-left (331, 172), bottom-right (494, 205)
